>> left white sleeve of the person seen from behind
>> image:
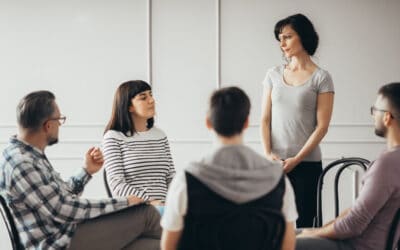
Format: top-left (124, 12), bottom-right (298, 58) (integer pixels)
top-left (161, 171), bottom-right (188, 231)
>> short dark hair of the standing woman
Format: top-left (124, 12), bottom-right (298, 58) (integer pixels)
top-left (274, 14), bottom-right (319, 56)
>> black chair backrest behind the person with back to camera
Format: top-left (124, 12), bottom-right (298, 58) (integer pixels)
top-left (215, 208), bottom-right (286, 250)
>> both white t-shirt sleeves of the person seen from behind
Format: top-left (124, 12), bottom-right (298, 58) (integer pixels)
top-left (161, 171), bottom-right (298, 231)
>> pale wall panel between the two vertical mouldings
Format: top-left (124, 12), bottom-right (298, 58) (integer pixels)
top-left (152, 0), bottom-right (217, 141)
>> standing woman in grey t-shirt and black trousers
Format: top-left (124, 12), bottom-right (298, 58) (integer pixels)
top-left (261, 14), bottom-right (334, 227)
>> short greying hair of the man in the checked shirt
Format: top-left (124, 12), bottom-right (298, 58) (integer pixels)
top-left (17, 90), bottom-right (55, 132)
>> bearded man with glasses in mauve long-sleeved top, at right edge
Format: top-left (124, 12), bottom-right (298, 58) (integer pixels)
top-left (296, 83), bottom-right (400, 250)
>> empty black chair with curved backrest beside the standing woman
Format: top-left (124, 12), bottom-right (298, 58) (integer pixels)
top-left (313, 157), bottom-right (370, 227)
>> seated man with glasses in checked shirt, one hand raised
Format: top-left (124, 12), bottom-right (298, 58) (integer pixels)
top-left (0, 91), bottom-right (161, 250)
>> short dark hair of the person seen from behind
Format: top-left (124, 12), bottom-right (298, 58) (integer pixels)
top-left (208, 87), bottom-right (250, 136)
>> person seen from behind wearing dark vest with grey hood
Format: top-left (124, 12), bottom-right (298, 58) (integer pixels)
top-left (161, 87), bottom-right (297, 250)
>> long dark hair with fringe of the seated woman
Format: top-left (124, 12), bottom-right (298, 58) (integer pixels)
top-left (104, 80), bottom-right (154, 136)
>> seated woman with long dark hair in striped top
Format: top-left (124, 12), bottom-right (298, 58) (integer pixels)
top-left (103, 80), bottom-right (175, 213)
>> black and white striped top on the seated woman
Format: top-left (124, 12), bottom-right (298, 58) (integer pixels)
top-left (103, 127), bottom-right (175, 201)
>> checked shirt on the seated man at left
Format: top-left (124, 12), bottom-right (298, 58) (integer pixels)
top-left (0, 137), bottom-right (128, 249)
